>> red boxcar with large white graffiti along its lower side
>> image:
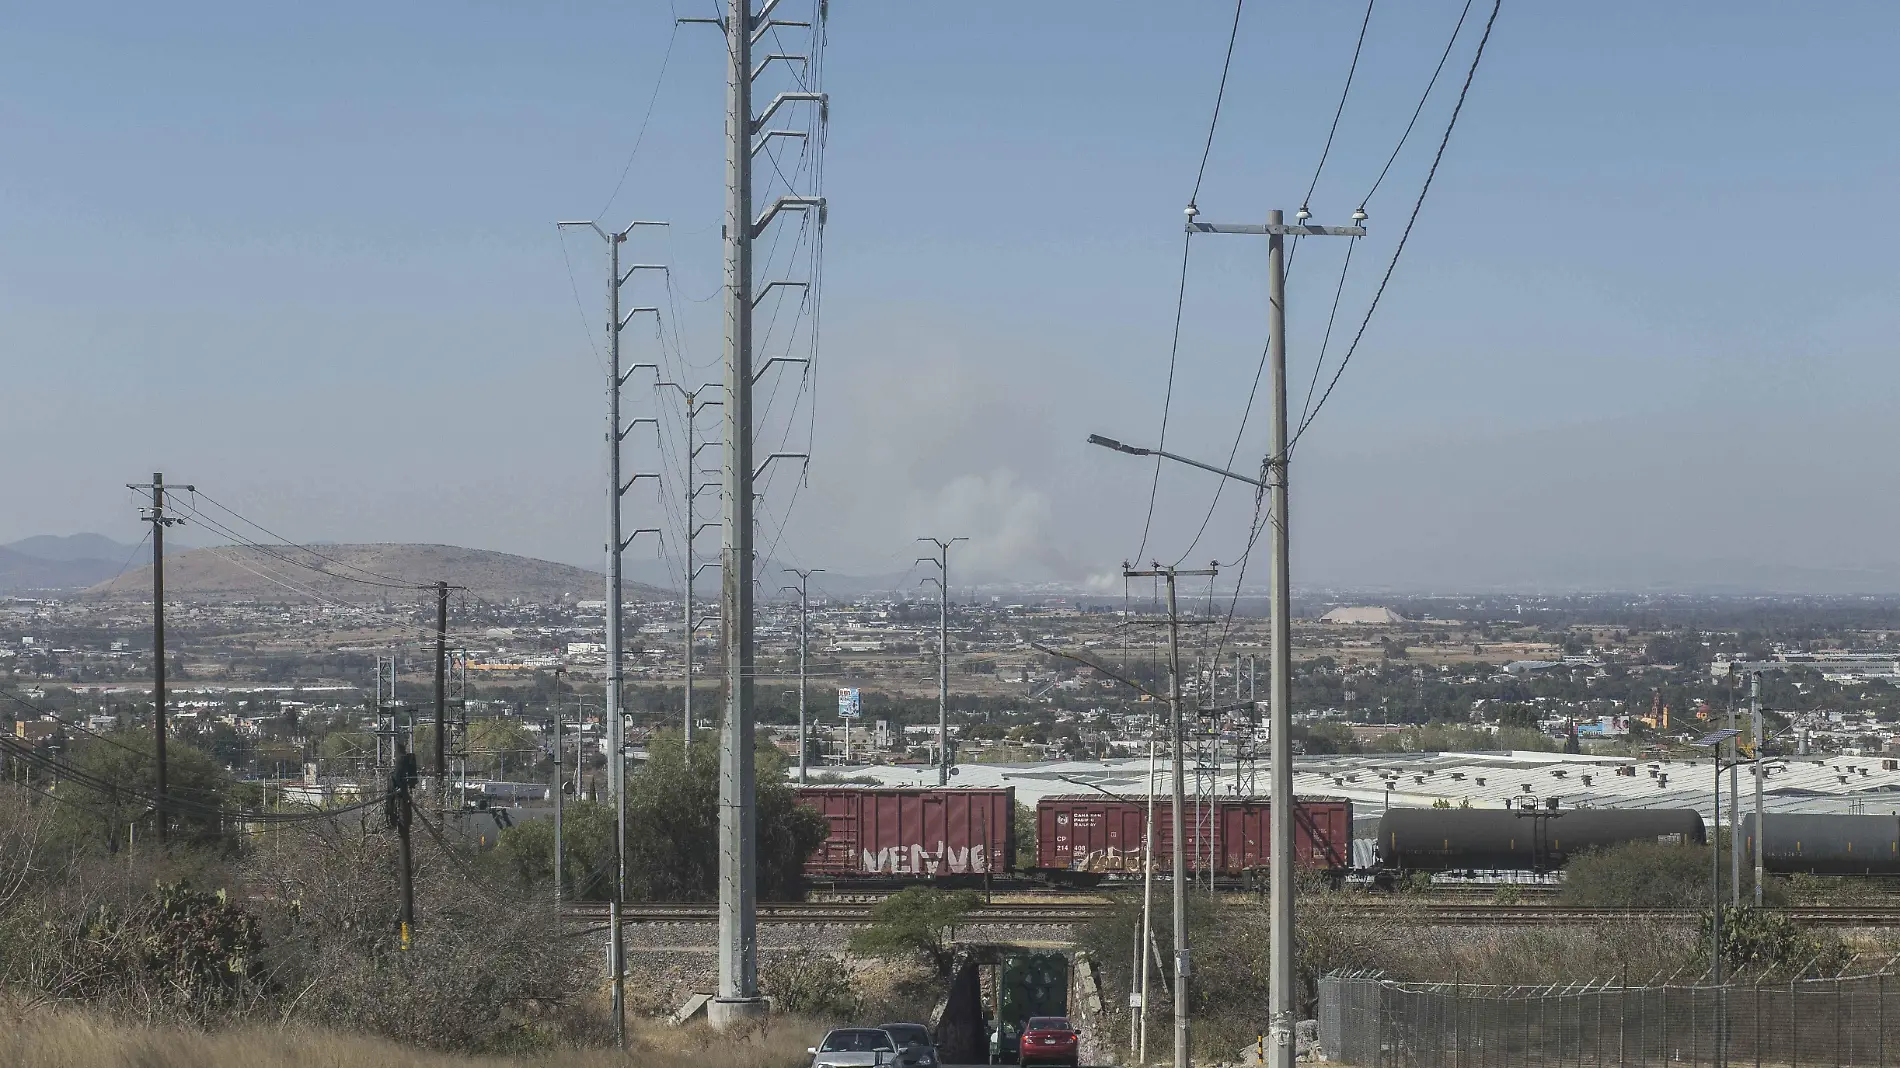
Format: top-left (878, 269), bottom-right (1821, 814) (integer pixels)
top-left (798, 787), bottom-right (1017, 878)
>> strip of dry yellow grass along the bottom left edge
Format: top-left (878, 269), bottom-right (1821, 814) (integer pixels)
top-left (0, 1011), bottom-right (825, 1068)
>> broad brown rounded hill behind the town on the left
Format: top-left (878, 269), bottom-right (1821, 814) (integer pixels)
top-left (86, 544), bottom-right (667, 604)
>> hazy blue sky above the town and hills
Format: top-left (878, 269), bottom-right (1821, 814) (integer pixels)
top-left (0, 0), bottom-right (1900, 585)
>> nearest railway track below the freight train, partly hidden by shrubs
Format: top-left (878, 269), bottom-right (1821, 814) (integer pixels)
top-left (564, 899), bottom-right (1900, 927)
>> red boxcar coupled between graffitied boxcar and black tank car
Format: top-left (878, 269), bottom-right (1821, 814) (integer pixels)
top-left (1036, 794), bottom-right (1353, 876)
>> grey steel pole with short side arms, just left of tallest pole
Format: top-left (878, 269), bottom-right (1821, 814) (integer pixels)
top-left (557, 220), bottom-right (667, 1049)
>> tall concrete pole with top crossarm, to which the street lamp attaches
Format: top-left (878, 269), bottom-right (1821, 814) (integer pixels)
top-left (1188, 203), bottom-right (1366, 1068)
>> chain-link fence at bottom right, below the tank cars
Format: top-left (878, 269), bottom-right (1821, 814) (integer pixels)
top-left (1319, 971), bottom-right (1900, 1068)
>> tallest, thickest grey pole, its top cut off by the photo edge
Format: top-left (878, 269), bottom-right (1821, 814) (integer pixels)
top-left (678, 0), bottom-right (825, 1028)
